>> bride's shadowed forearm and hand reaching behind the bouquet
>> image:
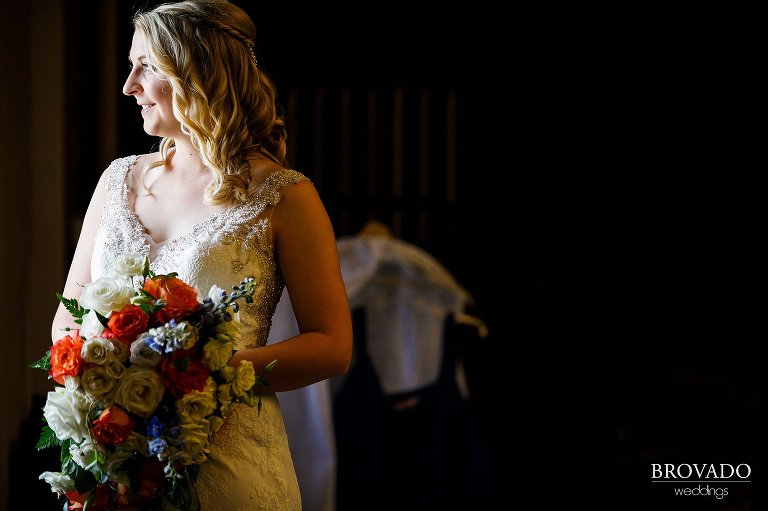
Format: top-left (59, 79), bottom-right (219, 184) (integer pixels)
top-left (229, 332), bottom-right (351, 392)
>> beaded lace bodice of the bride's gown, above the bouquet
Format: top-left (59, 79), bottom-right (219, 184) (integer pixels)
top-left (91, 155), bottom-right (307, 349)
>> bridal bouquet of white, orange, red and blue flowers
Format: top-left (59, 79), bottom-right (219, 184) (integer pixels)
top-left (30, 254), bottom-right (276, 511)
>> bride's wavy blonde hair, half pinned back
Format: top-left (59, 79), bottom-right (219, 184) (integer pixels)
top-left (132, 0), bottom-right (287, 204)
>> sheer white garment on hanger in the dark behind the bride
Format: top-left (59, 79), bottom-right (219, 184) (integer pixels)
top-left (337, 235), bottom-right (472, 394)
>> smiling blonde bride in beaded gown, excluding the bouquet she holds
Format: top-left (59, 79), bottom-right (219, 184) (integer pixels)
top-left (51, 0), bottom-right (352, 510)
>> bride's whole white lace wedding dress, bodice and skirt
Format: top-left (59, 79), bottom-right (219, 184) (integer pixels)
top-left (91, 156), bottom-right (306, 511)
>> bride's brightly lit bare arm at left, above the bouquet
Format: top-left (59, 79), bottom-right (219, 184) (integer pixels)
top-left (51, 166), bottom-right (112, 340)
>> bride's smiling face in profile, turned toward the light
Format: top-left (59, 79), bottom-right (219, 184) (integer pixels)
top-left (123, 30), bottom-right (180, 137)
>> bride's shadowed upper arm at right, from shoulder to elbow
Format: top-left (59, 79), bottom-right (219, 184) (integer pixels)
top-left (272, 181), bottom-right (352, 353)
